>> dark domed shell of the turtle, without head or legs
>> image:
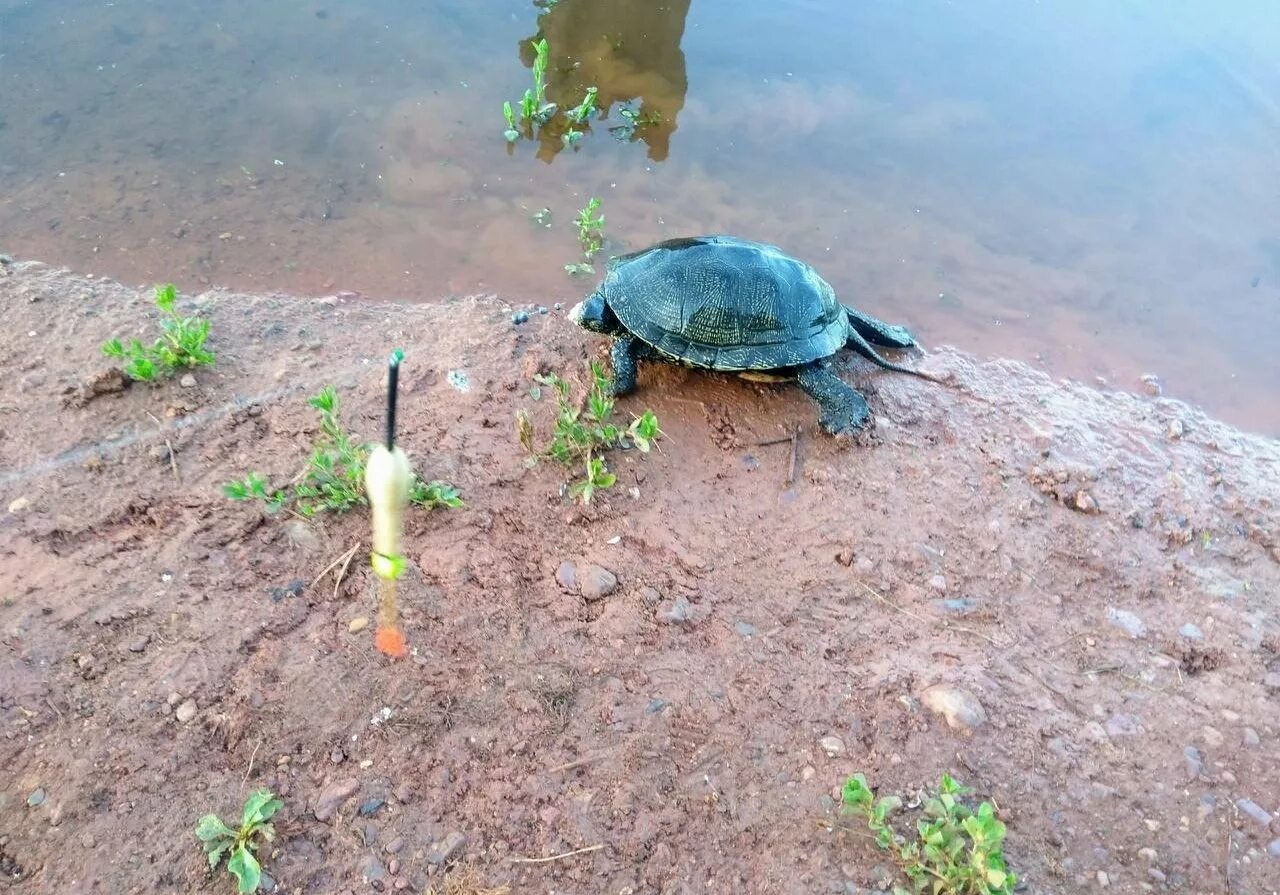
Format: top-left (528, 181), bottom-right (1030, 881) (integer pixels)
top-left (600, 236), bottom-right (849, 370)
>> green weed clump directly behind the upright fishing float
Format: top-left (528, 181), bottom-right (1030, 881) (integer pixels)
top-left (223, 385), bottom-right (462, 519)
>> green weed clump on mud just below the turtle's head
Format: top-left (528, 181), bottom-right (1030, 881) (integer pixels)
top-left (516, 361), bottom-right (662, 503)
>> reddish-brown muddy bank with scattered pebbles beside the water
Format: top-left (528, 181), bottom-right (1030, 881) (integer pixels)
top-left (0, 258), bottom-right (1280, 895)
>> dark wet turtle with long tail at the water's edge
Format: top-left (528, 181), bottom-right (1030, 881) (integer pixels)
top-left (570, 236), bottom-right (937, 435)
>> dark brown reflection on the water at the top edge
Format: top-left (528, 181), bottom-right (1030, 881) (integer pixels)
top-left (520, 0), bottom-right (692, 161)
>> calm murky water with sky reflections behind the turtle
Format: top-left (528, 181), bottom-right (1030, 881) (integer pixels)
top-left (0, 0), bottom-right (1280, 434)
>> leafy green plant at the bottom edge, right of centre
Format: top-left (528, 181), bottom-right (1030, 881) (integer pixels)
top-left (841, 773), bottom-right (1018, 895)
